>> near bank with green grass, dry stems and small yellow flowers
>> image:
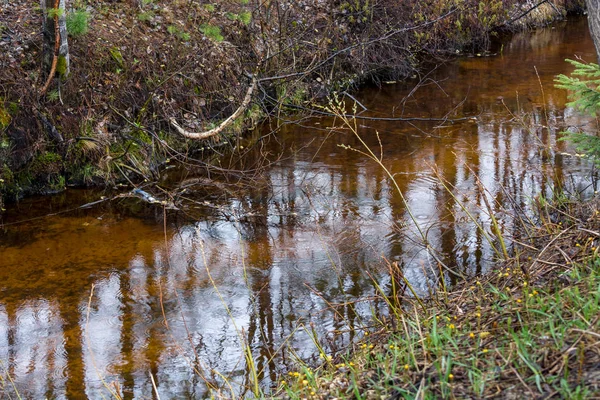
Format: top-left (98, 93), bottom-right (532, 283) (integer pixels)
top-left (277, 198), bottom-right (600, 399)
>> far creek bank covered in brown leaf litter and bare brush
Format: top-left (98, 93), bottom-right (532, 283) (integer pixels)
top-left (0, 0), bottom-right (583, 208)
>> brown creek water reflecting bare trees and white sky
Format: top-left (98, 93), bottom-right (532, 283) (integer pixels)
top-left (0, 20), bottom-right (597, 399)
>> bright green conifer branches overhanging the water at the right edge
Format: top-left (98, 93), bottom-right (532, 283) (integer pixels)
top-left (554, 60), bottom-right (600, 166)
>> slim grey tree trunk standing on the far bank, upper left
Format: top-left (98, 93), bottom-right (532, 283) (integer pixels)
top-left (41, 0), bottom-right (69, 76)
